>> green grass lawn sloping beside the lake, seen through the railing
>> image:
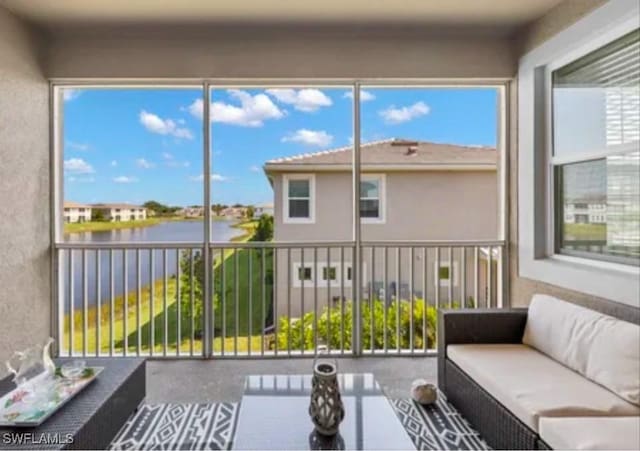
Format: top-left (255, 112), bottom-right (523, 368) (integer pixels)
top-left (63, 223), bottom-right (273, 354)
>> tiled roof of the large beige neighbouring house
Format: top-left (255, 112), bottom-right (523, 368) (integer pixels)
top-left (265, 138), bottom-right (497, 170)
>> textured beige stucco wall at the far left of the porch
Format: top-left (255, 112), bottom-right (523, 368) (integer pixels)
top-left (0, 8), bottom-right (50, 376)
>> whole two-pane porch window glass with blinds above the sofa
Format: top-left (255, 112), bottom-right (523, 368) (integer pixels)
top-left (551, 30), bottom-right (640, 265)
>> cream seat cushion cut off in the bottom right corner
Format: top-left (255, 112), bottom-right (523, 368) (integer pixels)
top-left (540, 417), bottom-right (640, 450)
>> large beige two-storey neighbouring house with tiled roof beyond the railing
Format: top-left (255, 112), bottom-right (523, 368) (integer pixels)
top-left (265, 139), bottom-right (499, 316)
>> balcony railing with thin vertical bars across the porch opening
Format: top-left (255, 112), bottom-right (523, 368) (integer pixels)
top-left (56, 241), bottom-right (505, 358)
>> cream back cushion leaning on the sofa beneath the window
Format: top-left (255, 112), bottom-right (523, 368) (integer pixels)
top-left (522, 294), bottom-right (640, 405)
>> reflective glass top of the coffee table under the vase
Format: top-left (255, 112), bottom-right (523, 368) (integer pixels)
top-left (233, 373), bottom-right (415, 450)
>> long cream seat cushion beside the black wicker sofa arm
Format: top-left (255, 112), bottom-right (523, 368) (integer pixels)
top-left (447, 344), bottom-right (640, 431)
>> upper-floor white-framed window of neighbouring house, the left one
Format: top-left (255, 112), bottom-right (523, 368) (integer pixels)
top-left (283, 175), bottom-right (315, 223)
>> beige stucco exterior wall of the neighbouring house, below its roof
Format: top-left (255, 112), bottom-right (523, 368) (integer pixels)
top-left (272, 171), bottom-right (498, 316)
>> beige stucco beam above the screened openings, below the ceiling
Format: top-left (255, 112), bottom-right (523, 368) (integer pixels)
top-left (47, 26), bottom-right (516, 79)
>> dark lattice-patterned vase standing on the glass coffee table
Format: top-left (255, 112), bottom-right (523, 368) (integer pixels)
top-left (309, 357), bottom-right (344, 435)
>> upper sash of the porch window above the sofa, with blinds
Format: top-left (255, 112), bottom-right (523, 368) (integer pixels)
top-left (552, 30), bottom-right (640, 158)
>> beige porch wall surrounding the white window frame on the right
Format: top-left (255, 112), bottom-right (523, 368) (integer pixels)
top-left (509, 0), bottom-right (640, 322)
